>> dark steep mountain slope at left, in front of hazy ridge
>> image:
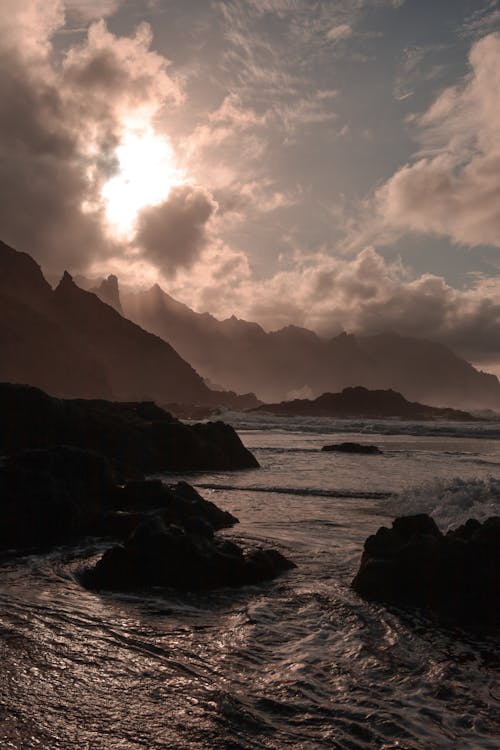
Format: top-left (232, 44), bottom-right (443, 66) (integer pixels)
top-left (0, 243), bottom-right (238, 404)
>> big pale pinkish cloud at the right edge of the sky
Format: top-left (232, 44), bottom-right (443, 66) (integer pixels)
top-left (377, 34), bottom-right (500, 247)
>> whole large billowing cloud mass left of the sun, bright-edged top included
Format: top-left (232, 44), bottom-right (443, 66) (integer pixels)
top-left (0, 0), bottom-right (188, 274)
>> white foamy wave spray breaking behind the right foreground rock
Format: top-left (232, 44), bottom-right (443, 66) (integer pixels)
top-left (384, 477), bottom-right (500, 531)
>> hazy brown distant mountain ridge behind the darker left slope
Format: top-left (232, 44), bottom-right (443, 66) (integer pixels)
top-left (122, 285), bottom-right (500, 409)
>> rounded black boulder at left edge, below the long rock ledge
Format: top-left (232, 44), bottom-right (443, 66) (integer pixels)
top-left (0, 446), bottom-right (112, 550)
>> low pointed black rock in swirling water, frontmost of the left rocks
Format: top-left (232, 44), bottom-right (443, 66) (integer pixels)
top-left (82, 516), bottom-right (295, 591)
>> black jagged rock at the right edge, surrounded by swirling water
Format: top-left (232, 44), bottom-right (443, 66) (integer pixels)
top-left (352, 515), bottom-right (500, 626)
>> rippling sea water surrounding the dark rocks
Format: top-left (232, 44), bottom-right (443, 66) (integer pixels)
top-left (0, 414), bottom-right (500, 750)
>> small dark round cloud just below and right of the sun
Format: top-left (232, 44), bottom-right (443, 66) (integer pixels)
top-left (135, 185), bottom-right (217, 274)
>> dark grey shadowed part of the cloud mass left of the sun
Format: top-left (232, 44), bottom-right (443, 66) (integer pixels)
top-left (0, 41), bottom-right (106, 271)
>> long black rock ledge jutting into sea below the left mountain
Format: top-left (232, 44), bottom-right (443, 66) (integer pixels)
top-left (0, 383), bottom-right (258, 476)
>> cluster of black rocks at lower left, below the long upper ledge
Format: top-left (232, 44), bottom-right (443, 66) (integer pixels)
top-left (0, 438), bottom-right (295, 590)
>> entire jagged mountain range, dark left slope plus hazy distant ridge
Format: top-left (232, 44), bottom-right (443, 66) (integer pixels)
top-left (0, 242), bottom-right (500, 410)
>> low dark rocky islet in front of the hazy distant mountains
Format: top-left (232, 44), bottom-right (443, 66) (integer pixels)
top-left (252, 386), bottom-right (475, 421)
